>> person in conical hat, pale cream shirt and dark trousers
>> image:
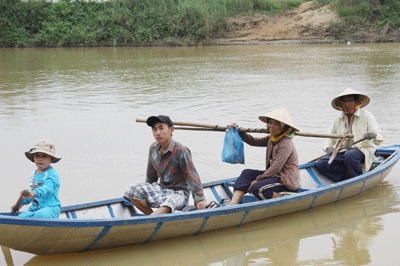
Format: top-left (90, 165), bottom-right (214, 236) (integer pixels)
top-left (316, 89), bottom-right (383, 182)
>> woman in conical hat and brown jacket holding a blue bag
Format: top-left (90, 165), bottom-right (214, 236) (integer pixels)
top-left (229, 108), bottom-right (300, 205)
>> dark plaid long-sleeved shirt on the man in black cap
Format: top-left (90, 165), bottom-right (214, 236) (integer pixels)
top-left (146, 139), bottom-right (204, 204)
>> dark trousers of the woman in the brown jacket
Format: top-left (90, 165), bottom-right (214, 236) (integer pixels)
top-left (233, 169), bottom-right (292, 200)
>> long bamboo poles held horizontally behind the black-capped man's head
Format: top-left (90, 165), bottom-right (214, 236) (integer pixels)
top-left (136, 118), bottom-right (354, 139)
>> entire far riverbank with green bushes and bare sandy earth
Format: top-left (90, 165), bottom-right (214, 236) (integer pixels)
top-left (0, 0), bottom-right (400, 47)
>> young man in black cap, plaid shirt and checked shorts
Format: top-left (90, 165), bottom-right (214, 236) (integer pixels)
top-left (124, 115), bottom-right (206, 215)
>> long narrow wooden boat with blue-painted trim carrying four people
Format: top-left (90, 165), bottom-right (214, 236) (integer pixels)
top-left (0, 145), bottom-right (400, 254)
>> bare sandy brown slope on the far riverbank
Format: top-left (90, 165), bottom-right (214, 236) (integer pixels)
top-left (210, 1), bottom-right (400, 45)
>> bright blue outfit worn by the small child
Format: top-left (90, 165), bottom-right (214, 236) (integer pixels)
top-left (18, 166), bottom-right (61, 218)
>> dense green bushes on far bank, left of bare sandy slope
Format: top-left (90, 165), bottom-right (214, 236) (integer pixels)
top-left (0, 0), bottom-right (302, 47)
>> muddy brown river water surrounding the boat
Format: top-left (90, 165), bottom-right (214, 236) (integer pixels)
top-left (0, 43), bottom-right (400, 266)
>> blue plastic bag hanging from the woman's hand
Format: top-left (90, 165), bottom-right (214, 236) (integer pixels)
top-left (222, 127), bottom-right (244, 164)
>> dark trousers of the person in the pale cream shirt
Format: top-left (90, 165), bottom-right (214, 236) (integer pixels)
top-left (315, 149), bottom-right (365, 182)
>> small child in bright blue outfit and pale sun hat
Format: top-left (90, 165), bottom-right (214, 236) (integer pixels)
top-left (12, 140), bottom-right (61, 218)
